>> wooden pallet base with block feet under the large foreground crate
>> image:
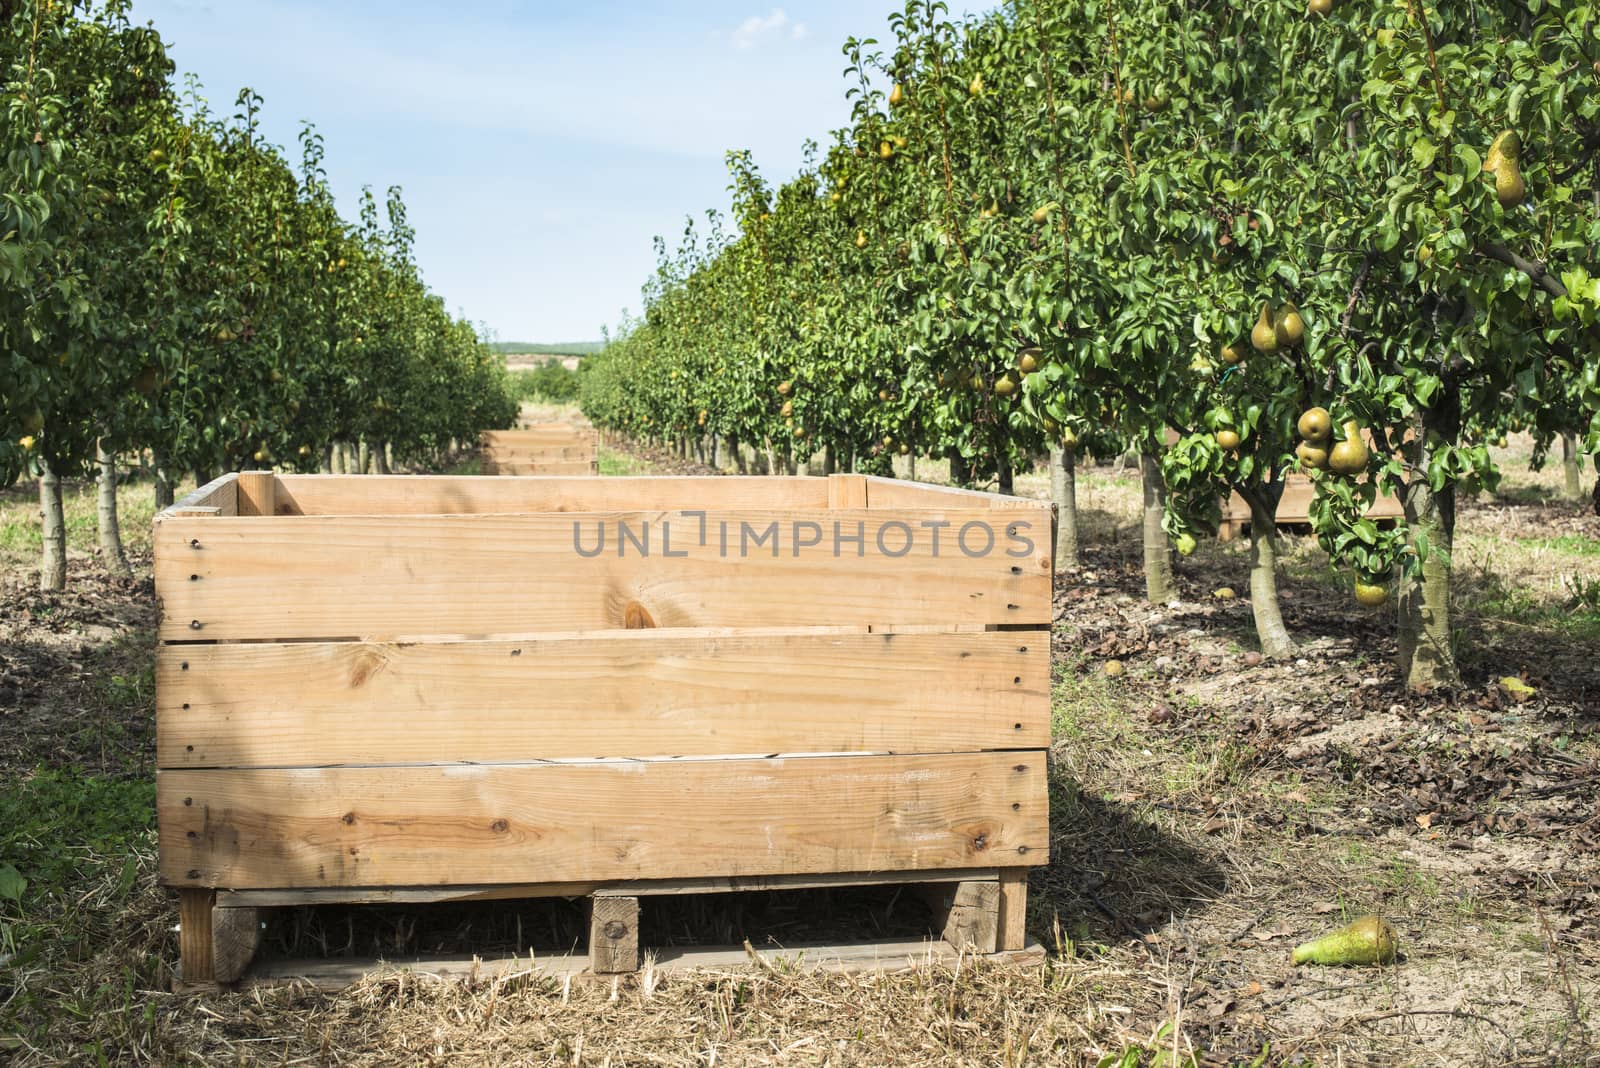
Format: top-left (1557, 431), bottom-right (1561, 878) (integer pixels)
top-left (174, 868), bottom-right (1045, 993)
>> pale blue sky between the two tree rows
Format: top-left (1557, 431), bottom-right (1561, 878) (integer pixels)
top-left (124, 0), bottom-right (979, 342)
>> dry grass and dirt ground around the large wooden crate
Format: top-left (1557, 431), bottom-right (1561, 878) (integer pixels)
top-left (0, 443), bottom-right (1600, 1068)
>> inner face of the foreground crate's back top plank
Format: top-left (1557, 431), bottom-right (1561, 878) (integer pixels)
top-left (278, 475), bottom-right (832, 515)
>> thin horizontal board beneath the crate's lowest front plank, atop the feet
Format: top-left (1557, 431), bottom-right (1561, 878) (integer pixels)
top-left (216, 868), bottom-right (1000, 910)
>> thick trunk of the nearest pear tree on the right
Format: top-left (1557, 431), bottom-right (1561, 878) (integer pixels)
top-left (1398, 404), bottom-right (1461, 691)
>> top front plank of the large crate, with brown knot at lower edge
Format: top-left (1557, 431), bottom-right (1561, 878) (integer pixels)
top-left (155, 511), bottom-right (1051, 641)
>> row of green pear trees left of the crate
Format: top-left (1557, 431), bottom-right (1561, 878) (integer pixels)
top-left (0, 0), bottom-right (515, 588)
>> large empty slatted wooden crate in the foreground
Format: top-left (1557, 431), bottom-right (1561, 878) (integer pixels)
top-left (155, 472), bottom-right (1054, 983)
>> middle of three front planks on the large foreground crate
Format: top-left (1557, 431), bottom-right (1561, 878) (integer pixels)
top-left (155, 630), bottom-right (1050, 767)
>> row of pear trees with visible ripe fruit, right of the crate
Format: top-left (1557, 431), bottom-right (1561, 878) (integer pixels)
top-left (582, 0), bottom-right (1600, 686)
